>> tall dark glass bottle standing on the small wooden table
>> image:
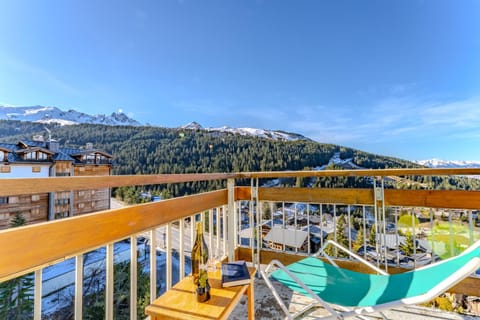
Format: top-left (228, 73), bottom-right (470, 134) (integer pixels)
top-left (192, 222), bottom-right (210, 302)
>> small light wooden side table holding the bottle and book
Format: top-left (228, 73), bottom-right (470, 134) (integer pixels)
top-left (145, 267), bottom-right (256, 320)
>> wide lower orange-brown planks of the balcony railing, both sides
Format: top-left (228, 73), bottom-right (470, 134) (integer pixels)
top-left (0, 184), bottom-right (480, 280)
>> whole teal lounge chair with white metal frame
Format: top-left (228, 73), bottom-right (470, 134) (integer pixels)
top-left (261, 241), bottom-right (480, 319)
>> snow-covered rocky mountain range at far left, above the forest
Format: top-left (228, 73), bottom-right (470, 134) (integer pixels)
top-left (0, 106), bottom-right (141, 126)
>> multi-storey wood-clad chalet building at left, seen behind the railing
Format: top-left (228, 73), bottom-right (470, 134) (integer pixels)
top-left (0, 136), bottom-right (112, 229)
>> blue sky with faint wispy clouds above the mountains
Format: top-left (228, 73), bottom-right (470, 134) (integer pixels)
top-left (0, 0), bottom-right (480, 160)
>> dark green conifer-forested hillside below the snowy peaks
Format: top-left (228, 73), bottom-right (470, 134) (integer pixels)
top-left (0, 121), bottom-right (478, 195)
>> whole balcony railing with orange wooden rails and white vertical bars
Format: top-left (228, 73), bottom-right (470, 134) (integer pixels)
top-left (0, 169), bottom-right (480, 319)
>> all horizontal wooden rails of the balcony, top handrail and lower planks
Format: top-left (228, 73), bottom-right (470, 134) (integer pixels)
top-left (0, 168), bottom-right (480, 281)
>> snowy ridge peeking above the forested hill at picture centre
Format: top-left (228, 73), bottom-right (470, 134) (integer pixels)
top-left (180, 121), bottom-right (310, 141)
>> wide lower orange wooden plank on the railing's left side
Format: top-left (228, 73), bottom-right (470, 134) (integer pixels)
top-left (0, 190), bottom-right (227, 281)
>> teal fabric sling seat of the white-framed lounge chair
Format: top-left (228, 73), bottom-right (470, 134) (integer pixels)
top-left (271, 248), bottom-right (480, 307)
